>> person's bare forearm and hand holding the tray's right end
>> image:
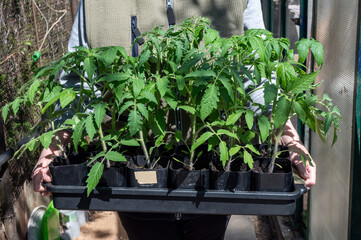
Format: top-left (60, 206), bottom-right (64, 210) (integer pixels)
top-left (280, 120), bottom-right (316, 189)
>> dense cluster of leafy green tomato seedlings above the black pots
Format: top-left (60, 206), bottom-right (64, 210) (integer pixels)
top-left (2, 18), bottom-right (340, 194)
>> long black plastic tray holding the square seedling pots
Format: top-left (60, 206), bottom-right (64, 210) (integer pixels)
top-left (45, 183), bottom-right (307, 215)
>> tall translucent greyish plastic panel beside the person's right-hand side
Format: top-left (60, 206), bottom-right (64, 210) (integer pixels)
top-left (309, 0), bottom-right (358, 239)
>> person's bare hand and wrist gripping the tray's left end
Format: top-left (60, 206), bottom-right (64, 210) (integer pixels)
top-left (32, 131), bottom-right (71, 196)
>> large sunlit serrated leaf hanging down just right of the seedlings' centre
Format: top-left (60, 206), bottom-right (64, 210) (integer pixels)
top-left (201, 84), bottom-right (219, 120)
